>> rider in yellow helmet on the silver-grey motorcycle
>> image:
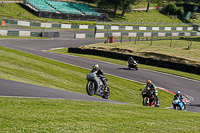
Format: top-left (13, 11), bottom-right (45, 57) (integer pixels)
top-left (91, 64), bottom-right (107, 88)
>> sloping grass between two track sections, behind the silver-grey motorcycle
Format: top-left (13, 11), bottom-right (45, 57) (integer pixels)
top-left (0, 47), bottom-right (172, 107)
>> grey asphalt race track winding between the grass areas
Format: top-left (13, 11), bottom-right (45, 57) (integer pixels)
top-left (0, 38), bottom-right (200, 112)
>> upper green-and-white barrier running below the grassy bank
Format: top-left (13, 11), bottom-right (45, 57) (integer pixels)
top-left (5, 19), bottom-right (200, 31)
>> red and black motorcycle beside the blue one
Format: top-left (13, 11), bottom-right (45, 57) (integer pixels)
top-left (140, 88), bottom-right (160, 107)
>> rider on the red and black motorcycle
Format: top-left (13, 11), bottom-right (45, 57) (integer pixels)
top-left (145, 80), bottom-right (160, 106)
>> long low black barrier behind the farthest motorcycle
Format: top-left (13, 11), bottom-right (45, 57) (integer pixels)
top-left (68, 48), bottom-right (200, 75)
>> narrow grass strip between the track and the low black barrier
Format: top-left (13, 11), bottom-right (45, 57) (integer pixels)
top-left (49, 45), bottom-right (200, 81)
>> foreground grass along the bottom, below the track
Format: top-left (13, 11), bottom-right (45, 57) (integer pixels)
top-left (0, 98), bottom-right (200, 133)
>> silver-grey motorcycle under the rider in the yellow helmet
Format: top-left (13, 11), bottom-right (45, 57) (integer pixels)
top-left (86, 72), bottom-right (110, 99)
